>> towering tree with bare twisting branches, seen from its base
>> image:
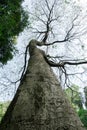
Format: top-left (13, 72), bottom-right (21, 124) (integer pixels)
top-left (0, 0), bottom-right (87, 130)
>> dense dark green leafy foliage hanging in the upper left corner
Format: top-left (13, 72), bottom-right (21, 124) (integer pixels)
top-left (0, 0), bottom-right (28, 64)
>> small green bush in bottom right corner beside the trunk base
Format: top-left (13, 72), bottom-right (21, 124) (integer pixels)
top-left (78, 109), bottom-right (87, 129)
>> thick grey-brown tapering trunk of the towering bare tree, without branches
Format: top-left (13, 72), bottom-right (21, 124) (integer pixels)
top-left (0, 41), bottom-right (85, 130)
